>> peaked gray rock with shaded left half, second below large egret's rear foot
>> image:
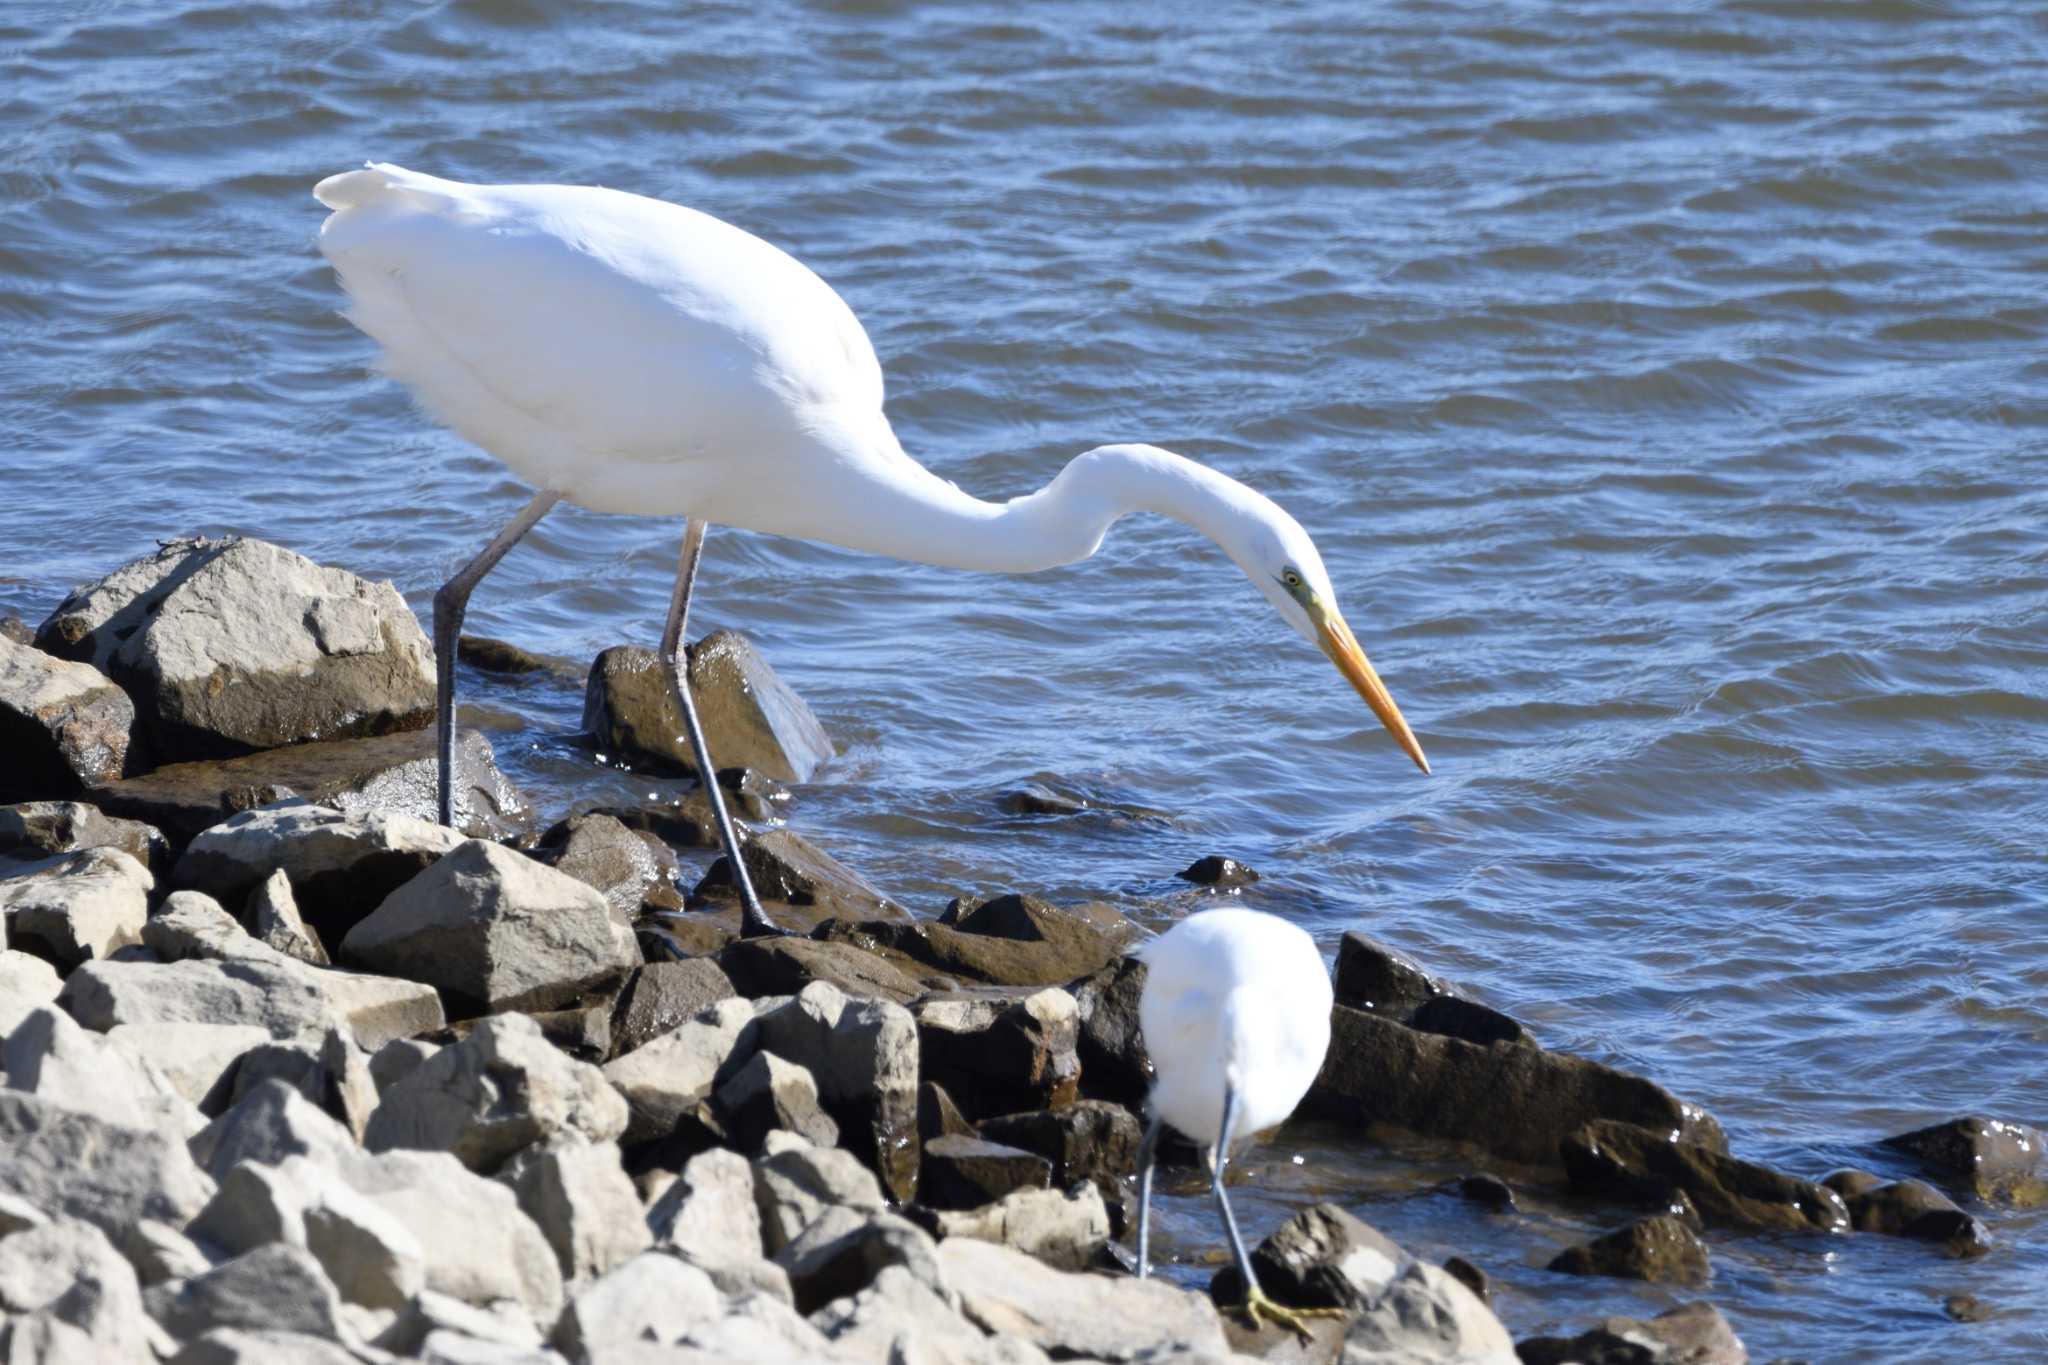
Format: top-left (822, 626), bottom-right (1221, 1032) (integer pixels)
top-left (362, 1015), bottom-right (627, 1173)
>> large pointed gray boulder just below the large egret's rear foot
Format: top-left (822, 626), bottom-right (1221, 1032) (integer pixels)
top-left (342, 839), bottom-right (639, 1013)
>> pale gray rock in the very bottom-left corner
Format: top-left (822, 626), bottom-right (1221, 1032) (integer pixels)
top-left (0, 1218), bottom-right (152, 1361)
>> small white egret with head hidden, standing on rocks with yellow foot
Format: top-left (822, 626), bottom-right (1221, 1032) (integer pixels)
top-left (1139, 909), bottom-right (1343, 1336)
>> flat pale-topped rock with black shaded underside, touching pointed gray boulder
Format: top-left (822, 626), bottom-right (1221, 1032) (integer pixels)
top-left (172, 800), bottom-right (463, 945)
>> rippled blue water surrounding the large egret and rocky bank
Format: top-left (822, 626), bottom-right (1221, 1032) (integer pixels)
top-left (0, 0), bottom-right (2048, 1361)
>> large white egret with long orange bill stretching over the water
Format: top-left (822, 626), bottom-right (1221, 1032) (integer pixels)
top-left (313, 164), bottom-right (1430, 933)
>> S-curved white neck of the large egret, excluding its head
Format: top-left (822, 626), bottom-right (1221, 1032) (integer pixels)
top-left (795, 430), bottom-right (1264, 573)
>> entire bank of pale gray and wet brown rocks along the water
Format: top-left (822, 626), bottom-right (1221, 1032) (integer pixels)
top-left (0, 540), bottom-right (2048, 1365)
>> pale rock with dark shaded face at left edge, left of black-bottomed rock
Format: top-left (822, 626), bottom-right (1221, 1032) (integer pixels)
top-left (0, 847), bottom-right (156, 970)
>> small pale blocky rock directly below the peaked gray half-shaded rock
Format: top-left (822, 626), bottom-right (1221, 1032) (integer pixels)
top-left (498, 1140), bottom-right (653, 1281)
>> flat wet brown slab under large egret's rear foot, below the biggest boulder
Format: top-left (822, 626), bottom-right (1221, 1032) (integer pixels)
top-left (92, 726), bottom-right (528, 845)
